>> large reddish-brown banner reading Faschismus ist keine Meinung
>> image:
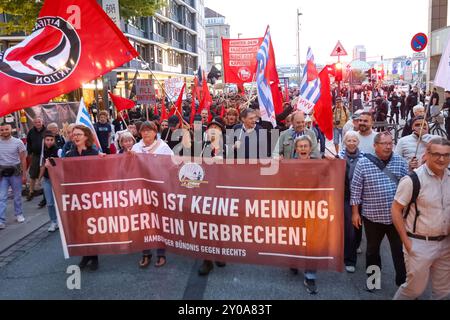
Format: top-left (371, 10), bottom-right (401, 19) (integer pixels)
top-left (50, 155), bottom-right (345, 271)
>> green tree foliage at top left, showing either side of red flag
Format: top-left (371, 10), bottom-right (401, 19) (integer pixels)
top-left (0, 0), bottom-right (167, 35)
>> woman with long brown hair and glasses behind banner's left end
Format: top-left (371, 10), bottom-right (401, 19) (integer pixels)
top-left (65, 125), bottom-right (99, 271)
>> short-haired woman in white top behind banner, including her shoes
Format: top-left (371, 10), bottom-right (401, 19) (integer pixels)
top-left (131, 121), bottom-right (174, 268)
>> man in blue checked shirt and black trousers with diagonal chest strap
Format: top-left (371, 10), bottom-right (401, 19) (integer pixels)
top-left (350, 133), bottom-right (408, 291)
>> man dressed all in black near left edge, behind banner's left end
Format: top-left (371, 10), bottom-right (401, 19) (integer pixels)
top-left (27, 117), bottom-right (46, 201)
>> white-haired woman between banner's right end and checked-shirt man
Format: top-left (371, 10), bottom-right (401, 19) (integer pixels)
top-left (339, 131), bottom-right (364, 273)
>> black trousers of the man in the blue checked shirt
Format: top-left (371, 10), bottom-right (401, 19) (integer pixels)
top-left (363, 218), bottom-right (406, 286)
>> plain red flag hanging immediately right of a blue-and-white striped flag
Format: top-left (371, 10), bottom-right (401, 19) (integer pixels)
top-left (314, 68), bottom-right (333, 140)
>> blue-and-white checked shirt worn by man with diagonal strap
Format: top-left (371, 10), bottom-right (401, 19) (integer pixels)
top-left (350, 154), bottom-right (408, 225)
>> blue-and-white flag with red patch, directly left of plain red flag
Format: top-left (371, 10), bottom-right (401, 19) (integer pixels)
top-left (297, 48), bottom-right (321, 114)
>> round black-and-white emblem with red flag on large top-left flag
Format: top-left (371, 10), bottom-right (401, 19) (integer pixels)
top-left (0, 17), bottom-right (81, 85)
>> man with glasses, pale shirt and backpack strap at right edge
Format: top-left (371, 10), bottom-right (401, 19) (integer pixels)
top-left (392, 137), bottom-right (450, 300)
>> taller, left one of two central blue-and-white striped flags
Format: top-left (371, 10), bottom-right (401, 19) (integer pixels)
top-left (256, 27), bottom-right (277, 128)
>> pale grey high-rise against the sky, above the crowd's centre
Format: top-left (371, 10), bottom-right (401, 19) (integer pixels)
top-left (206, 8), bottom-right (230, 71)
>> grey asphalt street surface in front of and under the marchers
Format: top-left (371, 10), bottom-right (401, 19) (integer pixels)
top-left (0, 197), bottom-right (429, 300)
